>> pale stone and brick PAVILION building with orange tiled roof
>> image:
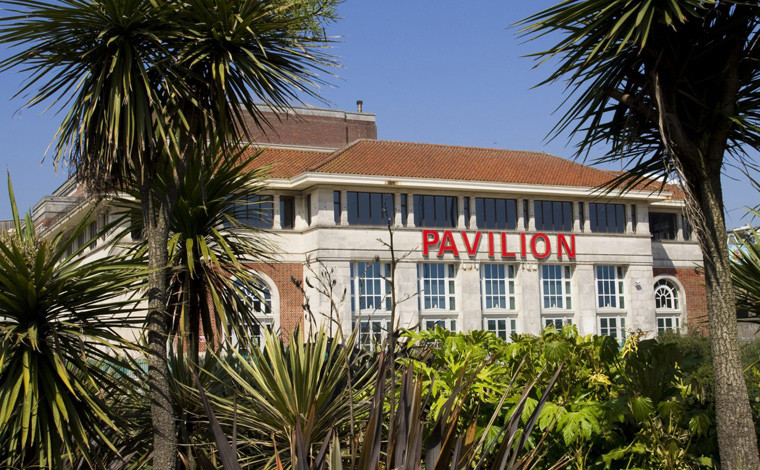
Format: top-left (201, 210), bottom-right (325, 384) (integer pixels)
top-left (29, 108), bottom-right (706, 341)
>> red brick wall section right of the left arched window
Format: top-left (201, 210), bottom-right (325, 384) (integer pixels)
top-left (251, 263), bottom-right (303, 337)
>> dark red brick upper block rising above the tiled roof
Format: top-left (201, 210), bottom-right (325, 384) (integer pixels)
top-left (242, 109), bottom-right (377, 148)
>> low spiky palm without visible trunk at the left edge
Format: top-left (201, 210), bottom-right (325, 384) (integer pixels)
top-left (0, 176), bottom-right (144, 468)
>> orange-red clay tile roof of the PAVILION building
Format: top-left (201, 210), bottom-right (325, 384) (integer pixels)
top-left (252, 140), bottom-right (680, 196)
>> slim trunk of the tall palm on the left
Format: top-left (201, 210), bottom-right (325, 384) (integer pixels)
top-left (140, 178), bottom-right (177, 470)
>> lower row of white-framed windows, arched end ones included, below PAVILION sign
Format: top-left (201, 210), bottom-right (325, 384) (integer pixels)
top-left (243, 270), bottom-right (681, 346)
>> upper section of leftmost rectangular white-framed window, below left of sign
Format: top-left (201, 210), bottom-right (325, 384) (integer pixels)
top-left (351, 262), bottom-right (391, 313)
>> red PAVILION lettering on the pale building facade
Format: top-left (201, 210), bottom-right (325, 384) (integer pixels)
top-left (422, 230), bottom-right (575, 259)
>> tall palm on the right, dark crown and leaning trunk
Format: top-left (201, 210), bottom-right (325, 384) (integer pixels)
top-left (521, 0), bottom-right (760, 469)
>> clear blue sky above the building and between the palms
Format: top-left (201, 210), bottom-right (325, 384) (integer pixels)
top-left (0, 0), bottom-right (760, 227)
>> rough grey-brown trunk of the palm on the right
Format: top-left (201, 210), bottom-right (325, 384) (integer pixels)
top-left (688, 165), bottom-right (760, 470)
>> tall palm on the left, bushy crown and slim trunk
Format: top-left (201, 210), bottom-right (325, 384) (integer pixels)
top-left (0, 0), bottom-right (336, 470)
